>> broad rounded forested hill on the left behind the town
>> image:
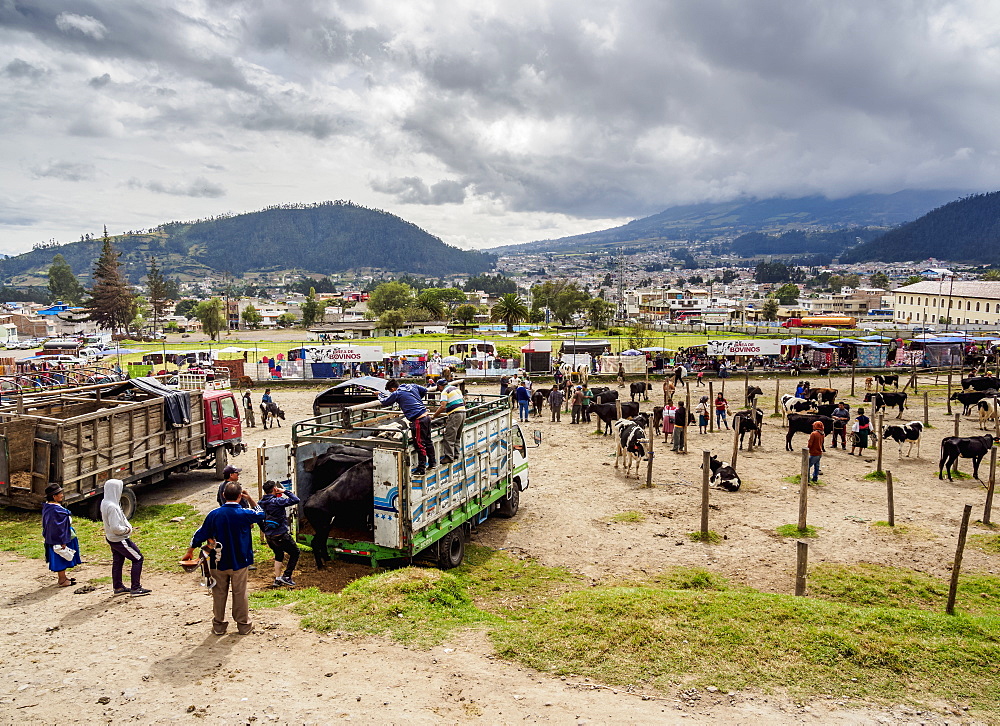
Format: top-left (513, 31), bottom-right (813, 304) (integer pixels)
top-left (0, 202), bottom-right (496, 282)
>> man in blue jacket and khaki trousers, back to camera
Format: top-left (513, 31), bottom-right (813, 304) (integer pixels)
top-left (184, 481), bottom-right (264, 635)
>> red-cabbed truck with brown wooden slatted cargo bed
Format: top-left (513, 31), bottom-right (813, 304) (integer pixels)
top-left (0, 379), bottom-right (246, 519)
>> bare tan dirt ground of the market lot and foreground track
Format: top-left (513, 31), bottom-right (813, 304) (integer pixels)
top-left (0, 378), bottom-right (997, 724)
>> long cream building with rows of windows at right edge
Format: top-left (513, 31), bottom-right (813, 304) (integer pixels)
top-left (892, 279), bottom-right (1000, 326)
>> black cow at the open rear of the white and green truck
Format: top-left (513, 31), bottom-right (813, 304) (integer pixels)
top-left (300, 444), bottom-right (375, 570)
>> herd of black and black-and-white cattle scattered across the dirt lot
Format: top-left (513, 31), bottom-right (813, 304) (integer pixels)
top-left (532, 375), bottom-right (1000, 491)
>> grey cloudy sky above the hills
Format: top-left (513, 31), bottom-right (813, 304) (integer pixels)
top-left (0, 0), bottom-right (1000, 252)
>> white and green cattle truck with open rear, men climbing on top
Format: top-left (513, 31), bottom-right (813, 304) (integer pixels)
top-left (292, 395), bottom-right (528, 568)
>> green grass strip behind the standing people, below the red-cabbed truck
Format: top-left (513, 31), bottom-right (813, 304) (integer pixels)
top-left (0, 504), bottom-right (266, 571)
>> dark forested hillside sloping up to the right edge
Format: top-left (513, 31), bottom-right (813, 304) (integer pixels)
top-left (840, 192), bottom-right (1000, 264)
